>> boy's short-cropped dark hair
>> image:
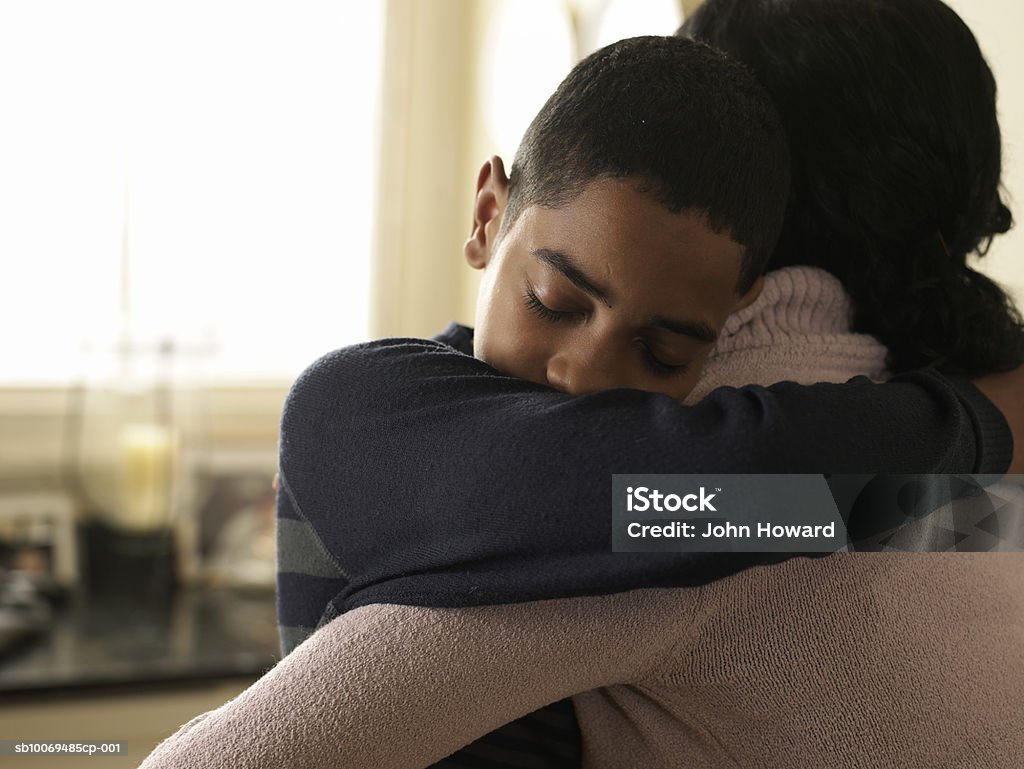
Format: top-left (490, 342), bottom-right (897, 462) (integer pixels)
top-left (502, 37), bottom-right (790, 293)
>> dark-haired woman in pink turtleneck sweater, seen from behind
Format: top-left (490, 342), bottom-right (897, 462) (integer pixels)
top-left (138, 0), bottom-right (1024, 767)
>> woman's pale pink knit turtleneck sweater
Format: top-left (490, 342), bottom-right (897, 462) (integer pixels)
top-left (142, 267), bottom-right (1024, 769)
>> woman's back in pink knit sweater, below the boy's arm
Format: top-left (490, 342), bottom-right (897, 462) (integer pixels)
top-left (573, 553), bottom-right (1024, 769)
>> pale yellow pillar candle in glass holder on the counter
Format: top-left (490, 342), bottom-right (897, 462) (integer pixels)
top-left (117, 423), bottom-right (177, 531)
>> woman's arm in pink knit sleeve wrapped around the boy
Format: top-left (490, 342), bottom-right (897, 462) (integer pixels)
top-left (132, 591), bottom-right (693, 769)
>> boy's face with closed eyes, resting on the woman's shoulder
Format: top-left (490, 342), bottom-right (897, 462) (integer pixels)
top-left (466, 158), bottom-right (761, 400)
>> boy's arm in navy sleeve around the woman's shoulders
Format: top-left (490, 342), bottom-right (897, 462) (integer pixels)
top-left (281, 339), bottom-right (1011, 613)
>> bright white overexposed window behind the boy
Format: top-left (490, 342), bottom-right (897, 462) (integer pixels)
top-left (0, 0), bottom-right (383, 384)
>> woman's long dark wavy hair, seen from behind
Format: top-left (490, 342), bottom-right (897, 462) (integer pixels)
top-left (677, 0), bottom-right (1024, 376)
